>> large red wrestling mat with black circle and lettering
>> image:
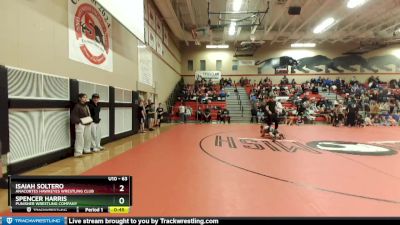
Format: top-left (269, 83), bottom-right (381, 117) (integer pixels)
top-left (3, 124), bottom-right (400, 217)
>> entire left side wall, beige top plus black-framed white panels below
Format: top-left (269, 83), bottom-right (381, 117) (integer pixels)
top-left (0, 0), bottom-right (181, 174)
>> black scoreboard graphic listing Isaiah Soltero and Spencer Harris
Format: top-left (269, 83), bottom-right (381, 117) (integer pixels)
top-left (8, 176), bottom-right (132, 213)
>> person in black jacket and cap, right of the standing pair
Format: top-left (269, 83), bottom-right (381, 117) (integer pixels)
top-left (89, 94), bottom-right (104, 152)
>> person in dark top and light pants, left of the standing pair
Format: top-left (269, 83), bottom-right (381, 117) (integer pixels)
top-left (71, 93), bottom-right (93, 157)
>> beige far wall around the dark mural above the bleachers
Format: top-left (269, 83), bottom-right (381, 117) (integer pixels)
top-left (182, 44), bottom-right (400, 83)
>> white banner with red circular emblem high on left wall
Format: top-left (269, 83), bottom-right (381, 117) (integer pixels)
top-left (68, 0), bottom-right (113, 72)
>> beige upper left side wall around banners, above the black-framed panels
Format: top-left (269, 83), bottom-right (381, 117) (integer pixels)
top-left (0, 0), bottom-right (181, 101)
